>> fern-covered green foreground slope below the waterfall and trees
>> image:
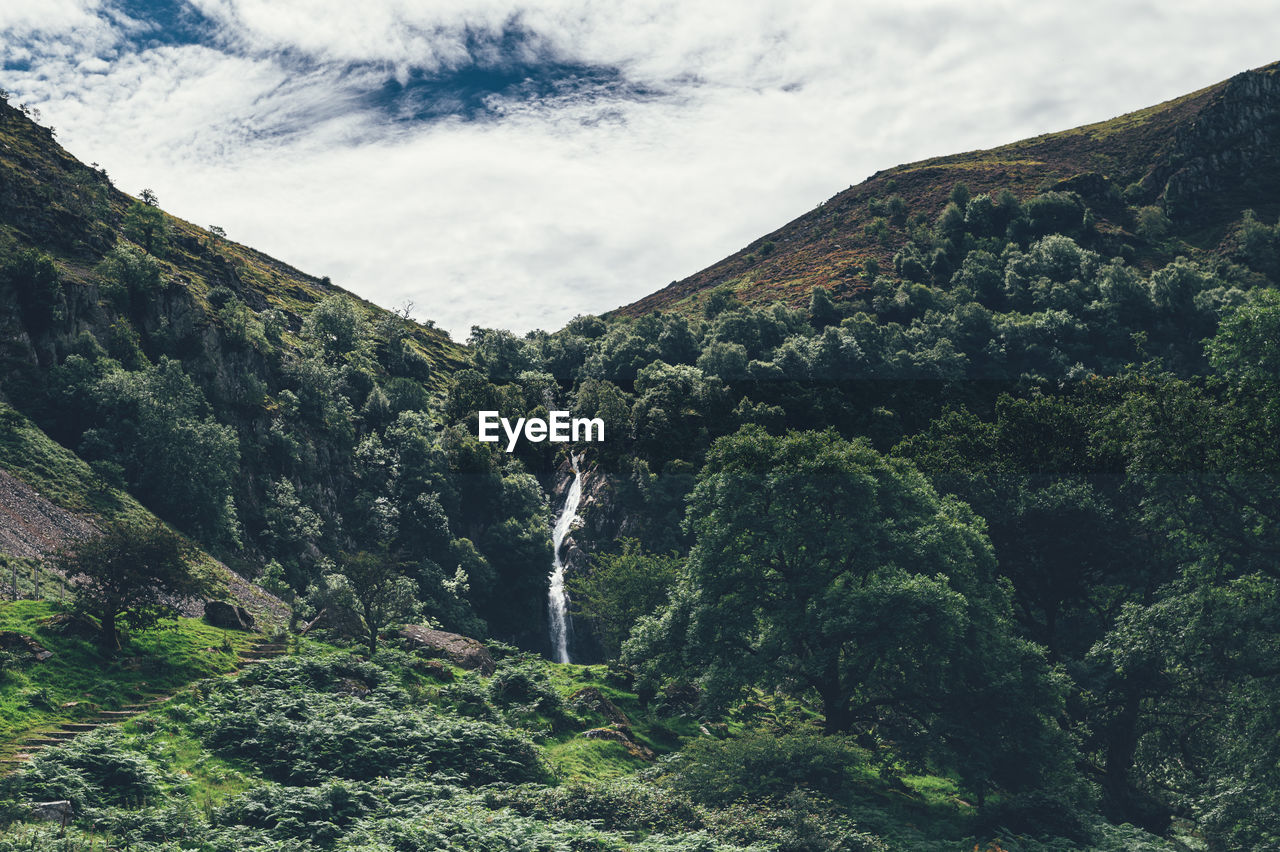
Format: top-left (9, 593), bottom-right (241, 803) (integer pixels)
top-left (0, 645), bottom-right (1174, 852)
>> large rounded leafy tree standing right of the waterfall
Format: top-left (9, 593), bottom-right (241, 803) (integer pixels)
top-left (623, 426), bottom-right (1071, 802)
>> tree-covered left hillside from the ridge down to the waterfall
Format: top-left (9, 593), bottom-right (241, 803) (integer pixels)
top-left (0, 93), bottom-right (565, 645)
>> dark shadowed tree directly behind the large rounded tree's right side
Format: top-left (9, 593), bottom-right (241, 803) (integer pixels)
top-left (893, 393), bottom-right (1170, 660)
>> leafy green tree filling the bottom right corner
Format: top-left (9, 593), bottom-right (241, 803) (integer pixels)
top-left (1085, 574), bottom-right (1280, 834)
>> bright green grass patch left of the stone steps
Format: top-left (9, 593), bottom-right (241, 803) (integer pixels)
top-left (0, 600), bottom-right (253, 753)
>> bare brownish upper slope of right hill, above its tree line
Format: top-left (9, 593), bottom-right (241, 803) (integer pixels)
top-left (614, 63), bottom-right (1280, 316)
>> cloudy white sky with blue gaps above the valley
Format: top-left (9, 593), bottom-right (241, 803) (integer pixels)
top-left (0, 0), bottom-right (1280, 340)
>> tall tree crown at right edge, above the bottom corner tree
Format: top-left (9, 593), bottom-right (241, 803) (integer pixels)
top-left (1105, 293), bottom-right (1280, 577)
